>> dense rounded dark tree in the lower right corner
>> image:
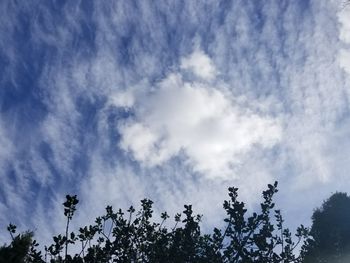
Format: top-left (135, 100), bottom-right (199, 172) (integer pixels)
top-left (305, 192), bottom-right (350, 263)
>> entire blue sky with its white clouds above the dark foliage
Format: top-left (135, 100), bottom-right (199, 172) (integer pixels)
top-left (0, 0), bottom-right (350, 245)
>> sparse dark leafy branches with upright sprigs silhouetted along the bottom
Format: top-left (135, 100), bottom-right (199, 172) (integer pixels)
top-left (0, 182), bottom-right (308, 263)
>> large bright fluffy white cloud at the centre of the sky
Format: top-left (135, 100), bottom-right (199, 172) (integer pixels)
top-left (119, 50), bottom-right (282, 178)
